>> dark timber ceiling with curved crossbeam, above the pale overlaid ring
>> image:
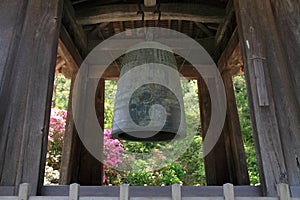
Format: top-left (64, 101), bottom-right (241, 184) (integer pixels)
top-left (63, 0), bottom-right (241, 76)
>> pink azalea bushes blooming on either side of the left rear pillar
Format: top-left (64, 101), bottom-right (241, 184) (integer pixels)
top-left (45, 108), bottom-right (124, 185)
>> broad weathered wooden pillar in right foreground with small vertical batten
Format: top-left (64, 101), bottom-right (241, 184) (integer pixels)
top-left (234, 0), bottom-right (300, 196)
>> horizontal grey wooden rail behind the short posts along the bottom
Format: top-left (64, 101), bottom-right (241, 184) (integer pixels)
top-left (41, 185), bottom-right (262, 198)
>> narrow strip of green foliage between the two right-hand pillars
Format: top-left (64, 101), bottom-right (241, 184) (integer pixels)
top-left (233, 75), bottom-right (260, 185)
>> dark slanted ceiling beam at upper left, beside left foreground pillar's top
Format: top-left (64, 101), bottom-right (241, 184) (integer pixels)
top-left (62, 0), bottom-right (87, 58)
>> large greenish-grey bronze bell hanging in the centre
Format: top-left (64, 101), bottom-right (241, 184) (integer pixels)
top-left (112, 41), bottom-right (186, 142)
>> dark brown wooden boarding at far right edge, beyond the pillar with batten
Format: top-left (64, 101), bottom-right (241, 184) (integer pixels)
top-left (266, 0), bottom-right (300, 185)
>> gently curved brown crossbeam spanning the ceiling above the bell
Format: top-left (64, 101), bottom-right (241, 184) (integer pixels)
top-left (76, 3), bottom-right (225, 24)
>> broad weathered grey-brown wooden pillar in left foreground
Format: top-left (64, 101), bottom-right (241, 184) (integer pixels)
top-left (0, 0), bottom-right (62, 195)
